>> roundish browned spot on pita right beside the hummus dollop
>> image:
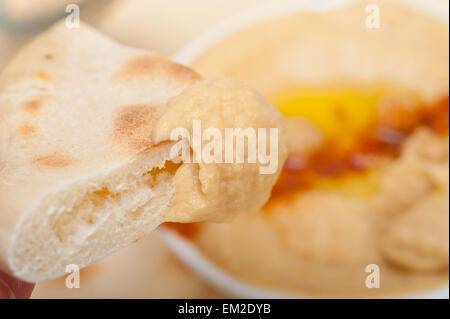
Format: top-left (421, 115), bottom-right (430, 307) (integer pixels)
top-left (113, 104), bottom-right (156, 151)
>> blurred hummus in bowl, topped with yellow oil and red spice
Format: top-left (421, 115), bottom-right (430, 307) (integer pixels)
top-left (161, 1), bottom-right (449, 298)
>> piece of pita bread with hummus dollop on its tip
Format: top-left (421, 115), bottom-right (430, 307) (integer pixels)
top-left (0, 23), bottom-right (286, 282)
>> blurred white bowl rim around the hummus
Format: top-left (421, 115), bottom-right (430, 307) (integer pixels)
top-left (158, 0), bottom-right (449, 299)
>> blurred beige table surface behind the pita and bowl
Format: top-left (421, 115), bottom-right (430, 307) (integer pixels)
top-left (0, 0), bottom-right (284, 298)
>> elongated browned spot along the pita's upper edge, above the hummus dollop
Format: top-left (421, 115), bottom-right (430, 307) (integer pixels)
top-left (113, 55), bottom-right (201, 82)
